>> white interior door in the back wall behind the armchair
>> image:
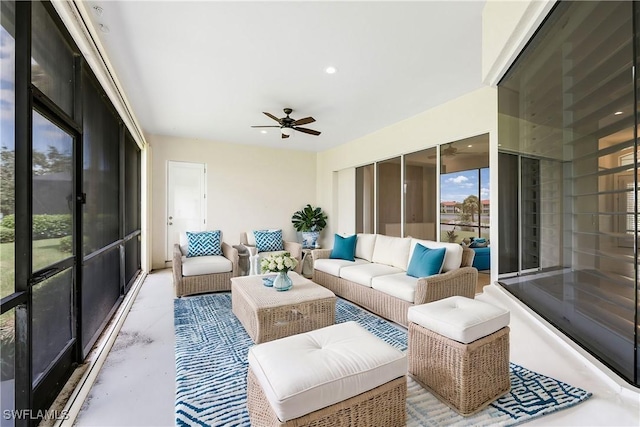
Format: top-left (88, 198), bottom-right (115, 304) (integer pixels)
top-left (165, 161), bottom-right (207, 260)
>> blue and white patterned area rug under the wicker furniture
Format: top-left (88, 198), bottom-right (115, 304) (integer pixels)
top-left (174, 293), bottom-right (591, 427)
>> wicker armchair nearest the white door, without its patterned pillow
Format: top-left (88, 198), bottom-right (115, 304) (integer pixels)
top-left (172, 235), bottom-right (238, 297)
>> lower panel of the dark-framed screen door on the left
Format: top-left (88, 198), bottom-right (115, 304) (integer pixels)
top-left (31, 268), bottom-right (73, 385)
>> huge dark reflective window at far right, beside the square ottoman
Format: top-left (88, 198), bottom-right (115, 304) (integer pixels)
top-left (498, 2), bottom-right (638, 383)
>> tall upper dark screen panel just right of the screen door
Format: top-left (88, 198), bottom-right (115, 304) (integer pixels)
top-left (82, 70), bottom-right (120, 255)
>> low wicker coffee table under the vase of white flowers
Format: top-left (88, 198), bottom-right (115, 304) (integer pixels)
top-left (231, 271), bottom-right (336, 344)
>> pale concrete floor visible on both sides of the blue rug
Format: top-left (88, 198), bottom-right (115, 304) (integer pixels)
top-left (74, 269), bottom-right (640, 426)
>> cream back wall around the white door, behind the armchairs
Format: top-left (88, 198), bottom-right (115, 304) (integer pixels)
top-left (147, 135), bottom-right (316, 269)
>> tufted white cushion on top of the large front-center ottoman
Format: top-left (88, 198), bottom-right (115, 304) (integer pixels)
top-left (248, 322), bottom-right (407, 422)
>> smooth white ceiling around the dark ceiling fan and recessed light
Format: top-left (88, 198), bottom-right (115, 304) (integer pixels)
top-left (85, 0), bottom-right (485, 151)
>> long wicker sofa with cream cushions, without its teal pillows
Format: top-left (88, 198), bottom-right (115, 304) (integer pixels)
top-left (312, 234), bottom-right (478, 326)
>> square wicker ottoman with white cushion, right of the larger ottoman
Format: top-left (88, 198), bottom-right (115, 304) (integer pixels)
top-left (407, 296), bottom-right (511, 416)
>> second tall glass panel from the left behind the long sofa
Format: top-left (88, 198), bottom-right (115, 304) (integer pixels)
top-left (376, 157), bottom-right (402, 237)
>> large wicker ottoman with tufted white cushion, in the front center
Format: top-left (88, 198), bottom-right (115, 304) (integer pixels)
top-left (247, 322), bottom-right (407, 427)
